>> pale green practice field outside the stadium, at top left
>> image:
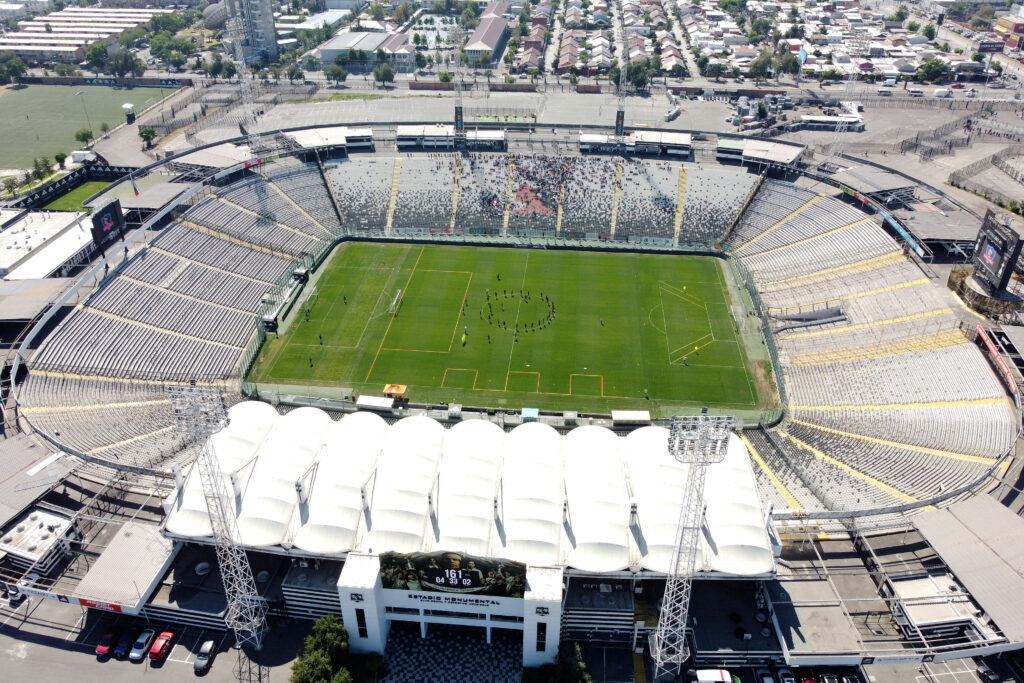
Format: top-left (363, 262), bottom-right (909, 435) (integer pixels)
top-left (0, 85), bottom-right (170, 169)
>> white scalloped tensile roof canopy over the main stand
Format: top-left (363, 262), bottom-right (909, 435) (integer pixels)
top-left (166, 401), bottom-right (774, 577)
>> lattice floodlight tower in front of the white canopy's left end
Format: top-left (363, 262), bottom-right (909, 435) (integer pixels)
top-left (166, 386), bottom-right (266, 650)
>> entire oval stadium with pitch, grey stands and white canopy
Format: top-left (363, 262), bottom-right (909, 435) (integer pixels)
top-left (3, 124), bottom-right (1024, 680)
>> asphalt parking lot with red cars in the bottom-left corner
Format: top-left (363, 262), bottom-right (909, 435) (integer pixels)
top-left (0, 599), bottom-right (309, 683)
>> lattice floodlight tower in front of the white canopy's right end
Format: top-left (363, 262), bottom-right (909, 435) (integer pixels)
top-left (650, 415), bottom-right (733, 681)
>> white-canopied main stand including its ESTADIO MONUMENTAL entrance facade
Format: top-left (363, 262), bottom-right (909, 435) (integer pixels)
top-left (164, 401), bottom-right (774, 666)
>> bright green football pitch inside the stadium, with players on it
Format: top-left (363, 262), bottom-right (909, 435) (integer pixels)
top-left (249, 243), bottom-right (777, 415)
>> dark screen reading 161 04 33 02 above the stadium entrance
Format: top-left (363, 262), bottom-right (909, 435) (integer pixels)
top-left (380, 552), bottom-right (526, 598)
